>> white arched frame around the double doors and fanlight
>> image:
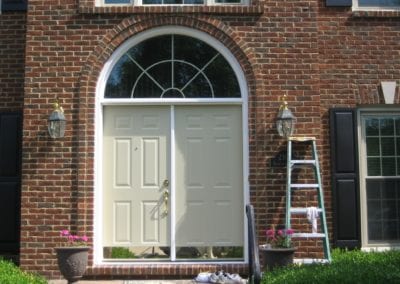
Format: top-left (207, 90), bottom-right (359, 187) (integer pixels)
top-left (93, 26), bottom-right (249, 265)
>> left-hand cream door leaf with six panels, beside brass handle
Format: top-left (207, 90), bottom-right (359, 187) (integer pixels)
top-left (103, 106), bottom-right (170, 247)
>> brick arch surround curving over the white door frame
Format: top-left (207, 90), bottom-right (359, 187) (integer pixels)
top-left (77, 15), bottom-right (262, 274)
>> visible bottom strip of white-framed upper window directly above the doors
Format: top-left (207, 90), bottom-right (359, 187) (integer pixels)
top-left (102, 0), bottom-right (242, 6)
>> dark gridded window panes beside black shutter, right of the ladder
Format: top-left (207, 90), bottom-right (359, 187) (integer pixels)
top-left (362, 114), bottom-right (400, 245)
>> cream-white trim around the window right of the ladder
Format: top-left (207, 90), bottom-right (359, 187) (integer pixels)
top-left (357, 106), bottom-right (400, 251)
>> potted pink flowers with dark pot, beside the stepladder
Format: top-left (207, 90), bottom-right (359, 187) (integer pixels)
top-left (260, 228), bottom-right (296, 270)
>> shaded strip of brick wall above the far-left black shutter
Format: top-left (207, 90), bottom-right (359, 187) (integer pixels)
top-left (0, 12), bottom-right (26, 111)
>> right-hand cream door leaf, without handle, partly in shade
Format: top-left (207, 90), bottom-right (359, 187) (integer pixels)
top-left (175, 106), bottom-right (244, 247)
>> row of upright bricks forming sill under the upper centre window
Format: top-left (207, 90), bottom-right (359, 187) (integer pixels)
top-left (79, 5), bottom-right (263, 15)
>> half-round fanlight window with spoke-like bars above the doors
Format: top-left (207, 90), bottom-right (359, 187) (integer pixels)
top-left (104, 34), bottom-right (241, 99)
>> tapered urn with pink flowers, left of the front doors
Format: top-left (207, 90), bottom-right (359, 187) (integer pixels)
top-left (55, 230), bottom-right (89, 283)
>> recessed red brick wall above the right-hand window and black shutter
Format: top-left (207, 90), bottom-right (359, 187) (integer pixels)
top-left (318, 2), bottom-right (400, 251)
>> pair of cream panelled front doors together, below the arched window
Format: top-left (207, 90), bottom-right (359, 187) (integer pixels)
top-left (103, 105), bottom-right (244, 258)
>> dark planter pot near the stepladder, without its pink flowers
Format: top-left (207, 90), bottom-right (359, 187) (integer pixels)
top-left (260, 246), bottom-right (296, 270)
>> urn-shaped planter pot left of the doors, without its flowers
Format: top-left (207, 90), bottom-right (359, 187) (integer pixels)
top-left (56, 247), bottom-right (89, 283)
